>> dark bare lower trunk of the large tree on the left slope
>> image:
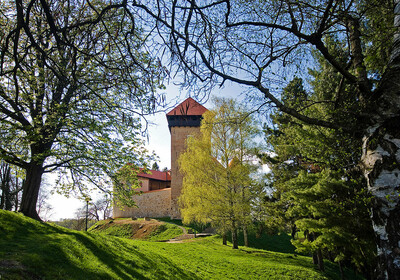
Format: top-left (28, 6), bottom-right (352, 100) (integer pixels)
top-left (19, 163), bottom-right (44, 221)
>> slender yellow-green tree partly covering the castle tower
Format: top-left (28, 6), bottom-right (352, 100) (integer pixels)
top-left (179, 99), bottom-right (258, 248)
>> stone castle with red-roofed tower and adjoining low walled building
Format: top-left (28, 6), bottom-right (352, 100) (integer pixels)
top-left (113, 97), bottom-right (207, 219)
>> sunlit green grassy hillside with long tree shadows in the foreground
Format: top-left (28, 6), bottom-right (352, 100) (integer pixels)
top-left (0, 210), bottom-right (362, 280)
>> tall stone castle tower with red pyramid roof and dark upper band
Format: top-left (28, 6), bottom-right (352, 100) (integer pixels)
top-left (167, 97), bottom-right (207, 219)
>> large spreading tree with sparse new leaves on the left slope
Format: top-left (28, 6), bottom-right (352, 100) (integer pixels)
top-left (0, 0), bottom-right (164, 218)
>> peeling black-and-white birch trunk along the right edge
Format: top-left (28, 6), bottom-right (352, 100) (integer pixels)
top-left (362, 0), bottom-right (400, 279)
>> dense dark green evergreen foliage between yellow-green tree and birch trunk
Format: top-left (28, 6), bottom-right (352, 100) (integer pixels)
top-left (265, 75), bottom-right (375, 273)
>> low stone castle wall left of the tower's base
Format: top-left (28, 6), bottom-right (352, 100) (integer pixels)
top-left (113, 188), bottom-right (171, 218)
